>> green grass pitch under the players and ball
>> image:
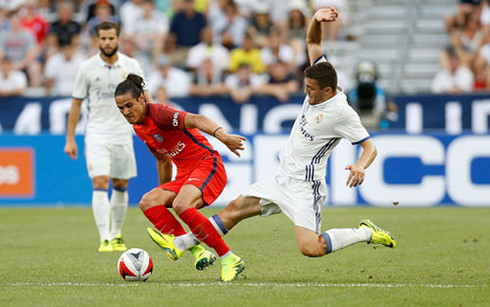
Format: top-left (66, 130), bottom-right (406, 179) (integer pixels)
top-left (0, 207), bottom-right (490, 306)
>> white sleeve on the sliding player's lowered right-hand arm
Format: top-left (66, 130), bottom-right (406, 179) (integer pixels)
top-left (334, 108), bottom-right (370, 145)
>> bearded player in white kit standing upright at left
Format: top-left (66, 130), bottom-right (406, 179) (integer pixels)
top-left (65, 22), bottom-right (152, 252)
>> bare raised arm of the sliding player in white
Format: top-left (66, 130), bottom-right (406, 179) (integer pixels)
top-left (306, 6), bottom-right (339, 65)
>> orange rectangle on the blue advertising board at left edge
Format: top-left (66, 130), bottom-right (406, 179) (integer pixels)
top-left (0, 148), bottom-right (34, 197)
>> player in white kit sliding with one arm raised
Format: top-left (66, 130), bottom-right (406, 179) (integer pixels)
top-left (166, 7), bottom-right (396, 282)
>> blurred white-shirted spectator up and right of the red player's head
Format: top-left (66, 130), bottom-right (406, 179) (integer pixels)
top-left (187, 27), bottom-right (230, 72)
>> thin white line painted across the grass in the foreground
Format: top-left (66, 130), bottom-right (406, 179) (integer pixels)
top-left (0, 281), bottom-right (487, 288)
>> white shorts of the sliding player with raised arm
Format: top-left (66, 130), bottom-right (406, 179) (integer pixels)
top-left (243, 175), bottom-right (327, 234)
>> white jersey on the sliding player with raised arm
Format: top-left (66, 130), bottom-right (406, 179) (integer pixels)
top-left (280, 58), bottom-right (370, 181)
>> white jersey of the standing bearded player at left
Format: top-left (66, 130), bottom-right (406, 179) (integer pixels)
top-left (72, 53), bottom-right (143, 144)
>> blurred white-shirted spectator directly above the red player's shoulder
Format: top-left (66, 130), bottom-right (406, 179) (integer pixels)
top-left (148, 55), bottom-right (192, 98)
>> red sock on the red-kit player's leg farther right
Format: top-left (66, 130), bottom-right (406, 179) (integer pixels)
top-left (179, 208), bottom-right (230, 257)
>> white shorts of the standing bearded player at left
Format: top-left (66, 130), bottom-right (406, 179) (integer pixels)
top-left (85, 143), bottom-right (136, 179)
